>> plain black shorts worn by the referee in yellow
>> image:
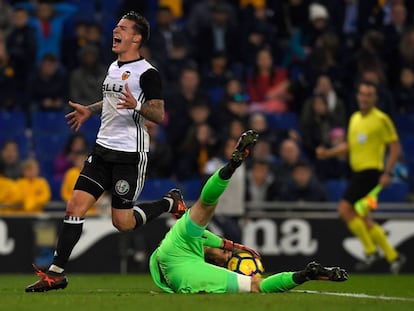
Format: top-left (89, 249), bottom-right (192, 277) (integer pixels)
top-left (343, 170), bottom-right (382, 205)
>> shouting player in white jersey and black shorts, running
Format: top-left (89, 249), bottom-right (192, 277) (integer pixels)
top-left (26, 12), bottom-right (185, 292)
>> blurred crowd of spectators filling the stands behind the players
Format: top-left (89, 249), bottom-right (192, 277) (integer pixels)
top-left (0, 0), bottom-right (414, 211)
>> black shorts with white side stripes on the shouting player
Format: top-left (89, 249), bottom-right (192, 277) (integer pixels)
top-left (74, 145), bottom-right (148, 209)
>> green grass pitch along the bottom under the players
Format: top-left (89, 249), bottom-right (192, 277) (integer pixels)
top-left (0, 274), bottom-right (414, 311)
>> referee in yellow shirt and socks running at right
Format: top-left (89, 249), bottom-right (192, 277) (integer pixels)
top-left (316, 81), bottom-right (406, 274)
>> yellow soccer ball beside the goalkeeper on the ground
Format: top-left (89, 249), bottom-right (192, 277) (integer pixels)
top-left (227, 252), bottom-right (264, 278)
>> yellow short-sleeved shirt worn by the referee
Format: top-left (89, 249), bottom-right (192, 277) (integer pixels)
top-left (347, 107), bottom-right (398, 172)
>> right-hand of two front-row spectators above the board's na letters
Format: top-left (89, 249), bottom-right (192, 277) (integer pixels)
top-left (279, 161), bottom-right (327, 202)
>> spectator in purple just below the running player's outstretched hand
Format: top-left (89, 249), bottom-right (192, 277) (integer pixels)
top-left (53, 133), bottom-right (88, 180)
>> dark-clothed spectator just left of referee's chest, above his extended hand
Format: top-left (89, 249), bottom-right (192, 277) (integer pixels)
top-left (300, 95), bottom-right (341, 158)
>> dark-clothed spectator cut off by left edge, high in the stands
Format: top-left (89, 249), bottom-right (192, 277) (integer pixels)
top-left (0, 30), bottom-right (17, 110)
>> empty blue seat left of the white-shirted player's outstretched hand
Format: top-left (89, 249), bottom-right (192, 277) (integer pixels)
top-left (32, 111), bottom-right (71, 134)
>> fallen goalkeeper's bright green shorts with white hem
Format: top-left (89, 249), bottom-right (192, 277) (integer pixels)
top-left (150, 212), bottom-right (246, 293)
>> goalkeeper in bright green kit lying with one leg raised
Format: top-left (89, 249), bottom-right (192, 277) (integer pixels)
top-left (150, 130), bottom-right (348, 293)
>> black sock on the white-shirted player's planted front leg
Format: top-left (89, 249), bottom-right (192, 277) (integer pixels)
top-left (53, 216), bottom-right (85, 269)
